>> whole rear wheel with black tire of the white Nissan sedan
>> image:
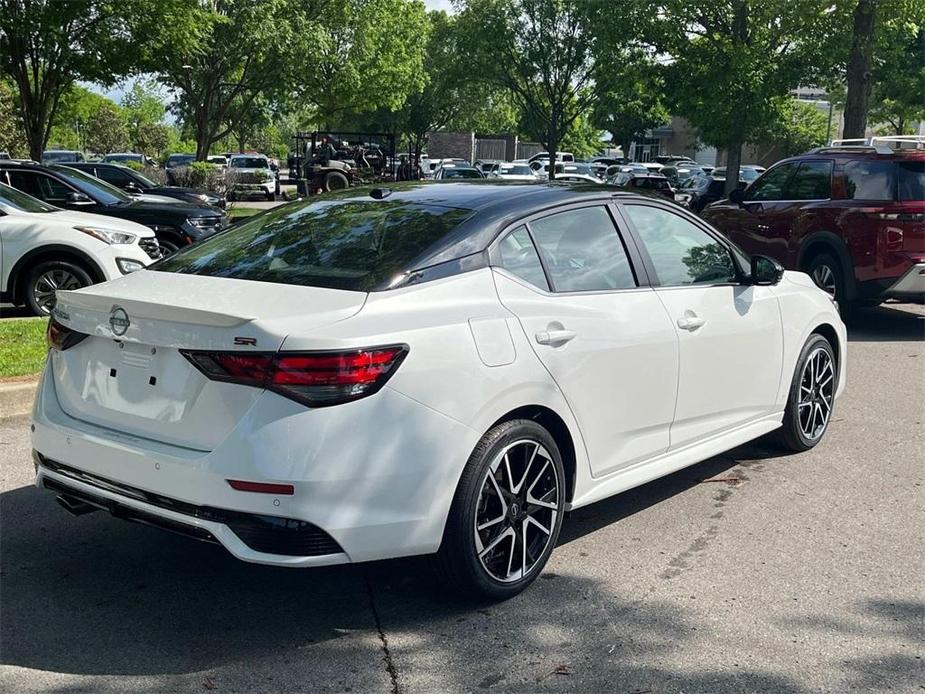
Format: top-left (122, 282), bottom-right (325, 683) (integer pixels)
top-left (435, 419), bottom-right (566, 600)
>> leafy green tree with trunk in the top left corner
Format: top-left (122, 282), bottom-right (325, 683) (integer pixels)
top-left (0, 0), bottom-right (199, 159)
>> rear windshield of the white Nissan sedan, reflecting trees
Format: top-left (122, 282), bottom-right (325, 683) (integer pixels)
top-left (150, 198), bottom-right (471, 292)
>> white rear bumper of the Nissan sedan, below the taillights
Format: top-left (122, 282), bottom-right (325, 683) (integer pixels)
top-left (32, 374), bottom-right (479, 567)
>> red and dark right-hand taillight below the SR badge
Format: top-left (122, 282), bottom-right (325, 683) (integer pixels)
top-left (180, 345), bottom-right (408, 407)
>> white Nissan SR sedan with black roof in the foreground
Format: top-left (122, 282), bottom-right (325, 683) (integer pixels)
top-left (33, 182), bottom-right (846, 599)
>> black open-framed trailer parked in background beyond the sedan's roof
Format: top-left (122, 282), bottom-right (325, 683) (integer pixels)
top-left (288, 130), bottom-right (397, 196)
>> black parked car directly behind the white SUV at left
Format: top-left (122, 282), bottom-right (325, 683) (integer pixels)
top-left (0, 161), bottom-right (228, 252)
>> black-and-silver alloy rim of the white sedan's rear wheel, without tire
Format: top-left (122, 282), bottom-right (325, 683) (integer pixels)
top-left (473, 439), bottom-right (562, 583)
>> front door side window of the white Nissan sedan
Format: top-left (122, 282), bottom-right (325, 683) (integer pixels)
top-left (625, 205), bottom-right (736, 286)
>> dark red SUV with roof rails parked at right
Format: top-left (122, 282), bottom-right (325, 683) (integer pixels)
top-left (702, 138), bottom-right (925, 308)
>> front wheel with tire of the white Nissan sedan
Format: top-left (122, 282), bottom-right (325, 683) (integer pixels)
top-left (778, 333), bottom-right (838, 453)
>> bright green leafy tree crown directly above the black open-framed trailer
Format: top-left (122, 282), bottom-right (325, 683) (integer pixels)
top-left (299, 0), bottom-right (429, 129)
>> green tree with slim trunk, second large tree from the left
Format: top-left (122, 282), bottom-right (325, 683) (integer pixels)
top-left (155, 0), bottom-right (296, 161)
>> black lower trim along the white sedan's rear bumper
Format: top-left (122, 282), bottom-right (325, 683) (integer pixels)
top-left (35, 452), bottom-right (344, 557)
